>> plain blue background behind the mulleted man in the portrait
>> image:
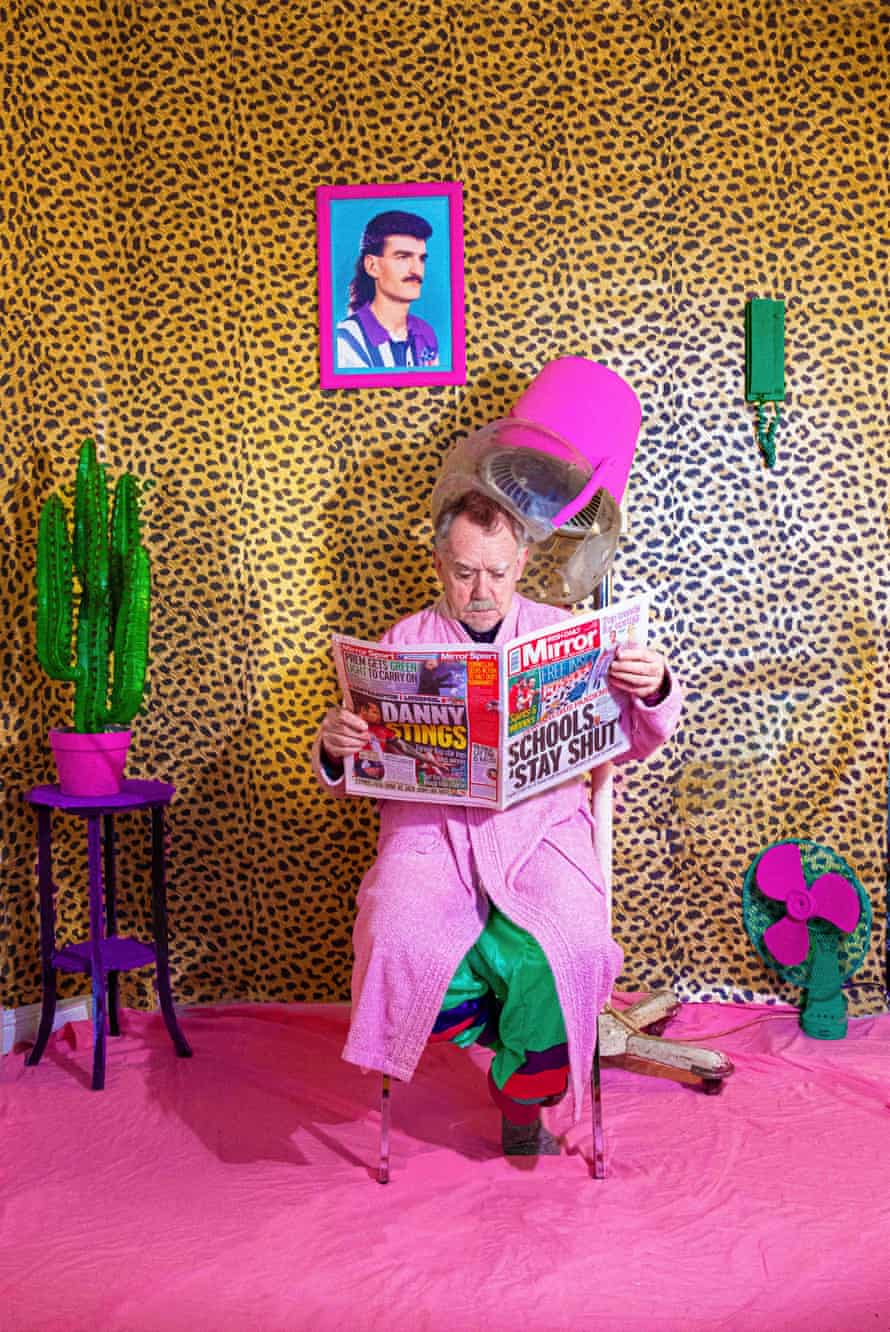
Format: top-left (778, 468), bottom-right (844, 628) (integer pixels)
top-left (330, 194), bottom-right (452, 374)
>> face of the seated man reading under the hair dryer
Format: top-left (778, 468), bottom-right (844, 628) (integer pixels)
top-left (436, 514), bottom-right (529, 630)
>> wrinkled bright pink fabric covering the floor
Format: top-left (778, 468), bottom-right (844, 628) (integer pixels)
top-left (0, 1004), bottom-right (890, 1332)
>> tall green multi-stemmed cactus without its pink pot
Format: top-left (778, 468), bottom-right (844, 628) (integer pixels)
top-left (37, 440), bottom-right (151, 733)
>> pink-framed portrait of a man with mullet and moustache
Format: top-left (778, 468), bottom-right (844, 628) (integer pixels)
top-left (316, 181), bottom-right (466, 389)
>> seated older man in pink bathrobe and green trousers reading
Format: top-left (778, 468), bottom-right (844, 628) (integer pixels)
top-left (313, 492), bottom-right (681, 1155)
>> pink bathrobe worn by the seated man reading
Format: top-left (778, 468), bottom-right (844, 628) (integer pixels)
top-left (313, 595), bottom-right (681, 1115)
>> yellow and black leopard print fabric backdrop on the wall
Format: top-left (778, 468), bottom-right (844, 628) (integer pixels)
top-left (0, 0), bottom-right (890, 1011)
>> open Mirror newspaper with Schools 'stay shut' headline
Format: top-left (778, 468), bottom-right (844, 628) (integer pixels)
top-left (333, 594), bottom-right (649, 810)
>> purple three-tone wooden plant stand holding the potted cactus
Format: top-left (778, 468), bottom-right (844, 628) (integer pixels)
top-left (25, 781), bottom-right (192, 1091)
